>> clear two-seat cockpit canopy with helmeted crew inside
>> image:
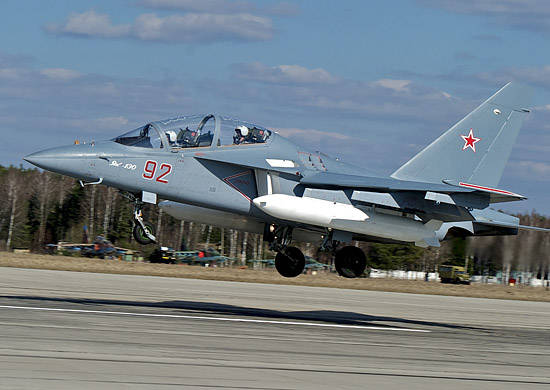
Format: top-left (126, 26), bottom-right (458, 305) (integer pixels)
top-left (113, 114), bottom-right (271, 149)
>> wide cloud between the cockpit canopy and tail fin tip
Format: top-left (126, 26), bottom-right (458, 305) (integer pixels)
top-left (232, 62), bottom-right (462, 122)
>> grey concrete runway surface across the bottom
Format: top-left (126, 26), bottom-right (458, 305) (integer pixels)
top-left (0, 268), bottom-right (550, 390)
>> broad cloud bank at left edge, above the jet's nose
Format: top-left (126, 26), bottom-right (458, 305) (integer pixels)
top-left (0, 56), bottom-right (194, 142)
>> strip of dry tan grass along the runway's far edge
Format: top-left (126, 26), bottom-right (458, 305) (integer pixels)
top-left (0, 252), bottom-right (550, 302)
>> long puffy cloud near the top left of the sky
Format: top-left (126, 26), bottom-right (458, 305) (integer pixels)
top-left (45, 10), bottom-right (274, 43)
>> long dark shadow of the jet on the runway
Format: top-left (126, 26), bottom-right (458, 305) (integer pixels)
top-left (0, 295), bottom-right (485, 331)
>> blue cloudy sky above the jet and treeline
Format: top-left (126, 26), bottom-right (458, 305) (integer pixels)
top-left (0, 0), bottom-right (550, 215)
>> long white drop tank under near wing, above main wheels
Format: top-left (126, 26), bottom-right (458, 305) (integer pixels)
top-left (253, 194), bottom-right (441, 247)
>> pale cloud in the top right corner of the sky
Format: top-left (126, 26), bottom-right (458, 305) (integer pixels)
top-left (417, 0), bottom-right (550, 32)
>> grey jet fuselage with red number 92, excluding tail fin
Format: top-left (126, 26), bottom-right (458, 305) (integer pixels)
top-left (25, 115), bottom-right (528, 246)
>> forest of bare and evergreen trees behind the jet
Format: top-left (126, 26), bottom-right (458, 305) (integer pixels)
top-left (0, 166), bottom-right (550, 278)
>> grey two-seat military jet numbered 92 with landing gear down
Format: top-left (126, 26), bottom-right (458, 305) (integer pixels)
top-left (25, 83), bottom-right (545, 278)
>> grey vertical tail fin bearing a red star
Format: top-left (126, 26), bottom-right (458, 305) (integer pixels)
top-left (391, 83), bottom-right (532, 187)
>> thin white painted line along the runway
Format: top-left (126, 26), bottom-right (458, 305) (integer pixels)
top-left (0, 305), bottom-right (431, 333)
